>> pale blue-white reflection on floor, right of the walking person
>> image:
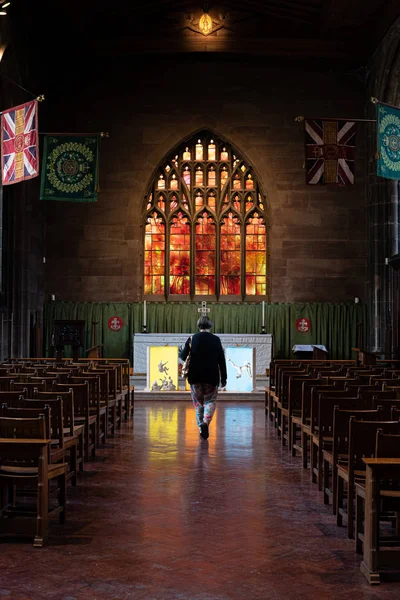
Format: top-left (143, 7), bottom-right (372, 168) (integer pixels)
top-left (225, 406), bottom-right (253, 456)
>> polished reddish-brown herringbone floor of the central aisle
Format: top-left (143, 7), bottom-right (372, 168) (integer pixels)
top-left (0, 402), bottom-right (400, 600)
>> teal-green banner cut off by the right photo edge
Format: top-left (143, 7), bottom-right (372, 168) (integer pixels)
top-left (376, 103), bottom-right (400, 179)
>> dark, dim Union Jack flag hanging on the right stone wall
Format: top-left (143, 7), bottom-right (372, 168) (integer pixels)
top-left (304, 119), bottom-right (356, 185)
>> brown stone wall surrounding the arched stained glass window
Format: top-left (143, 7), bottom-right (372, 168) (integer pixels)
top-left (42, 55), bottom-right (366, 302)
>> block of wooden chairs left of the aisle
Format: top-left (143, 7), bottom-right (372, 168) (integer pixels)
top-left (0, 358), bottom-right (134, 546)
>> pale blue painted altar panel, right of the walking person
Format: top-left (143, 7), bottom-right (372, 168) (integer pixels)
top-left (225, 346), bottom-right (256, 392)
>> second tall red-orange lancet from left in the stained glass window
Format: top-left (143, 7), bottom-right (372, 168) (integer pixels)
top-left (169, 212), bottom-right (190, 294)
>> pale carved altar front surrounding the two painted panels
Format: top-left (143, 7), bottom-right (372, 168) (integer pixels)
top-left (133, 333), bottom-right (272, 376)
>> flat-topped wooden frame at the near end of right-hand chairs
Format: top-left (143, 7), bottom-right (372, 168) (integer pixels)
top-left (360, 458), bottom-right (400, 584)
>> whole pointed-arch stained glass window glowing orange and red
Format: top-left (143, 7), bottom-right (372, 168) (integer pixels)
top-left (144, 131), bottom-right (267, 300)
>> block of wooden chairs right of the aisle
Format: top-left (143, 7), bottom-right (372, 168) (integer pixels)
top-left (265, 361), bottom-right (400, 584)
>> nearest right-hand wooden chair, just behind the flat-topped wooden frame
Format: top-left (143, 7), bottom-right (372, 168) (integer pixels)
top-left (336, 417), bottom-right (400, 538)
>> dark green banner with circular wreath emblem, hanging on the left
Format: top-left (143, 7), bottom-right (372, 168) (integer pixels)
top-left (40, 135), bottom-right (99, 202)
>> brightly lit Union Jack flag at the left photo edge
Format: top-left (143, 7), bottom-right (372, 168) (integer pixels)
top-left (1, 100), bottom-right (39, 185)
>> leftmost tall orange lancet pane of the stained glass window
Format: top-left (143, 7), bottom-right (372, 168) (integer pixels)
top-left (144, 211), bottom-right (165, 295)
